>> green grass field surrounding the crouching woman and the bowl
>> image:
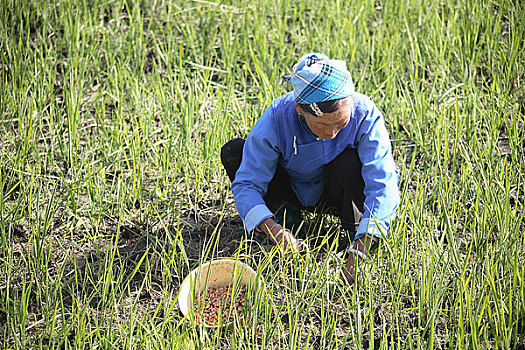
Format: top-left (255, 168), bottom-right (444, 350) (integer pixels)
top-left (0, 0), bottom-right (525, 349)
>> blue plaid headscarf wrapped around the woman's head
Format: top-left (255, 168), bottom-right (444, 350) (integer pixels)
top-left (290, 53), bottom-right (354, 104)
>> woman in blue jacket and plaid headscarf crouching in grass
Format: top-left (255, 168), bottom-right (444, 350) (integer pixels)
top-left (221, 53), bottom-right (399, 283)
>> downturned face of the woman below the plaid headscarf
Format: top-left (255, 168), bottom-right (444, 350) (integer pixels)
top-left (295, 98), bottom-right (353, 140)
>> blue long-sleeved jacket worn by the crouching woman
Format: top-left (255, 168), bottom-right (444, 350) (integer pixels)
top-left (232, 92), bottom-right (399, 239)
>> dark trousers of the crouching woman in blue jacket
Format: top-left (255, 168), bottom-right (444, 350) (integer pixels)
top-left (221, 138), bottom-right (365, 238)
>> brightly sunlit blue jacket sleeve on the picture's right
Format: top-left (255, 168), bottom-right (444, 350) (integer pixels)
top-left (355, 101), bottom-right (400, 239)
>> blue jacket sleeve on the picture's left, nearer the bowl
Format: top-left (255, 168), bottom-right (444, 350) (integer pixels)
top-left (231, 106), bottom-right (280, 231)
